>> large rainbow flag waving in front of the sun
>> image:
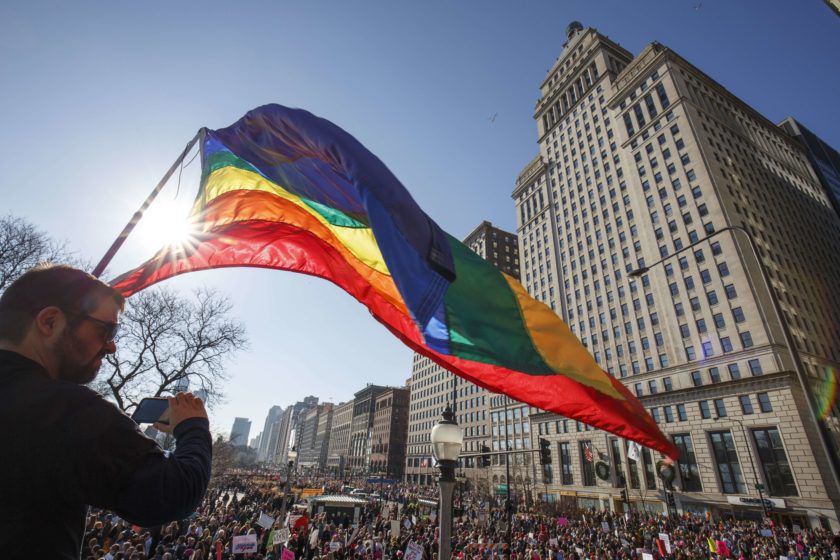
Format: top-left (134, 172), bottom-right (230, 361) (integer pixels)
top-left (114, 105), bottom-right (678, 458)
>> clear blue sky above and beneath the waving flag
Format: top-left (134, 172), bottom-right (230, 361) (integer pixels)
top-left (0, 0), bottom-right (840, 437)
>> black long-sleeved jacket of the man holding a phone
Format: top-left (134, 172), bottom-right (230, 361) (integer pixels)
top-left (0, 350), bottom-right (212, 560)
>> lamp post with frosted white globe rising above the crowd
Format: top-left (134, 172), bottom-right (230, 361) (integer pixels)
top-left (431, 405), bottom-right (464, 560)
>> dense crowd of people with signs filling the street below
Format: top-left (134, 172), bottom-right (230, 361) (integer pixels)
top-left (77, 474), bottom-right (840, 560)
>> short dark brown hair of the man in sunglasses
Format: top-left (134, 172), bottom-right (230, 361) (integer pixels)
top-left (0, 264), bottom-right (125, 344)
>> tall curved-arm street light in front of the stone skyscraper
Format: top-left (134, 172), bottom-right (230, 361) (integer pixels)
top-left (629, 226), bottom-right (840, 488)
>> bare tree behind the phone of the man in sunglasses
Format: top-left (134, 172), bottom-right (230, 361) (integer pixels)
top-left (93, 288), bottom-right (247, 412)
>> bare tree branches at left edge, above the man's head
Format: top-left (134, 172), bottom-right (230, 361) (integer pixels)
top-left (0, 214), bottom-right (78, 293)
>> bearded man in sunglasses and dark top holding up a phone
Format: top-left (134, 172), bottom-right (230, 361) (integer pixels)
top-left (0, 266), bottom-right (212, 560)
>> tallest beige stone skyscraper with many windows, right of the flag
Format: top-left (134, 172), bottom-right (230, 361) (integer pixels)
top-left (512, 22), bottom-right (840, 530)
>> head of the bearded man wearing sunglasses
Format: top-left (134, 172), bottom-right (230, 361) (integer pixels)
top-left (0, 265), bottom-right (125, 384)
